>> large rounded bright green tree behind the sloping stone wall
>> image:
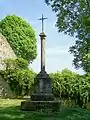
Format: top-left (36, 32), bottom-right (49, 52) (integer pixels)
top-left (0, 15), bottom-right (37, 62)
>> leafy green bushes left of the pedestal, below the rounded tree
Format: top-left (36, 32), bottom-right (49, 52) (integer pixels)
top-left (0, 58), bottom-right (36, 97)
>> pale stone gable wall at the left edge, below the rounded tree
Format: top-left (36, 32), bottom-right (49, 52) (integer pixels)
top-left (0, 33), bottom-right (16, 70)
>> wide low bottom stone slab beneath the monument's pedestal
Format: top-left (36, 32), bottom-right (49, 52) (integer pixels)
top-left (21, 101), bottom-right (61, 111)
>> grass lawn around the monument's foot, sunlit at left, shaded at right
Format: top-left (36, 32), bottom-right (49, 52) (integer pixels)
top-left (0, 99), bottom-right (90, 120)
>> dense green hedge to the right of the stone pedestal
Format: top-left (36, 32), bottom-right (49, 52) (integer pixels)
top-left (50, 69), bottom-right (90, 107)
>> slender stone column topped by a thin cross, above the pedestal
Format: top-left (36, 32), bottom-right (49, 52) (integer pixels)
top-left (38, 14), bottom-right (47, 71)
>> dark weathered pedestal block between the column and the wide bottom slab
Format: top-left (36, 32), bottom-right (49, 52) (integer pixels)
top-left (31, 71), bottom-right (54, 101)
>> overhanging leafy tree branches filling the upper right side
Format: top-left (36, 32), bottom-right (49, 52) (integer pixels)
top-left (45, 0), bottom-right (90, 73)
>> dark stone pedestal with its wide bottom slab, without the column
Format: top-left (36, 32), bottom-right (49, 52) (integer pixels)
top-left (21, 71), bottom-right (60, 110)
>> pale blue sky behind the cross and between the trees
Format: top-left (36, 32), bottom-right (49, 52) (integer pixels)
top-left (0, 0), bottom-right (83, 74)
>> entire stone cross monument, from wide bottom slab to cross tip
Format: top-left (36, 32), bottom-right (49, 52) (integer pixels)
top-left (21, 15), bottom-right (57, 110)
